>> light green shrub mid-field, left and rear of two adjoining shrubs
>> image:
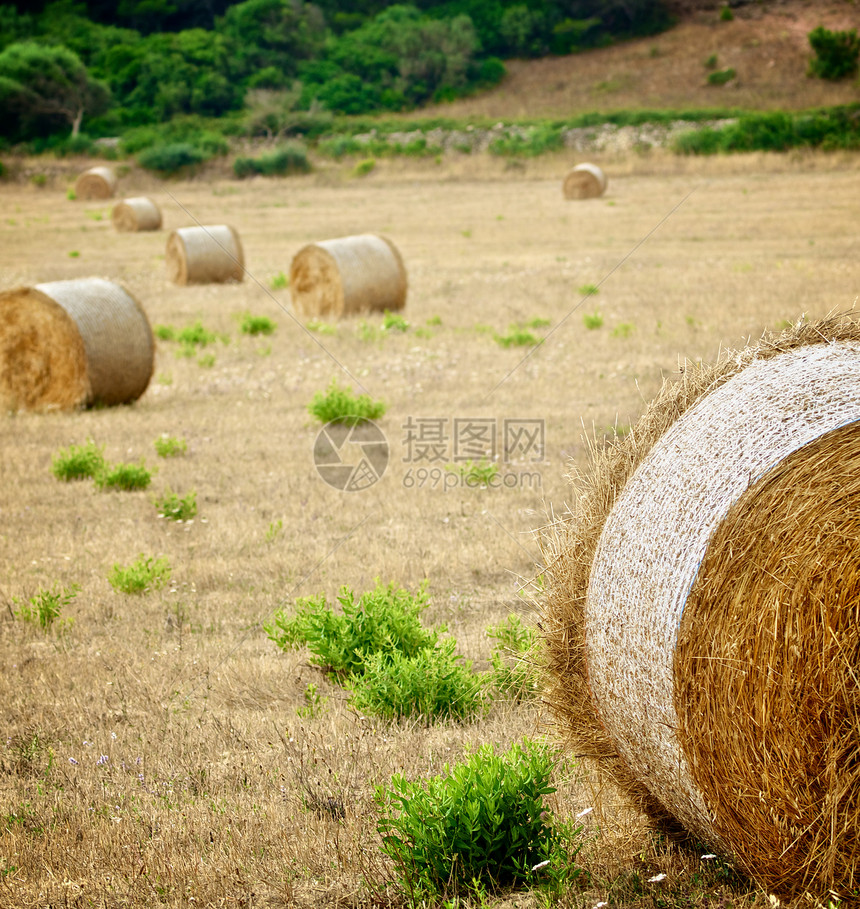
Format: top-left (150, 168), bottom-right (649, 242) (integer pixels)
top-left (264, 581), bottom-right (445, 677)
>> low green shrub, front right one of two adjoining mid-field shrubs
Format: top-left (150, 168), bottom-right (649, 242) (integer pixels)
top-left (347, 639), bottom-right (484, 722)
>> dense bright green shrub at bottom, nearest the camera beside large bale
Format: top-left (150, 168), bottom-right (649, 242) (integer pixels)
top-left (376, 740), bottom-right (579, 905)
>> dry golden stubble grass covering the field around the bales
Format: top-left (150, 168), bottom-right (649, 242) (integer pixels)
top-left (0, 147), bottom-right (860, 909)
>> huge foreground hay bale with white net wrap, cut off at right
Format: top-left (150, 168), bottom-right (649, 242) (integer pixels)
top-left (542, 317), bottom-right (860, 898)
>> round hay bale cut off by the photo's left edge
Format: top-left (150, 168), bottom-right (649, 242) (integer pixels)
top-left (0, 278), bottom-right (155, 410)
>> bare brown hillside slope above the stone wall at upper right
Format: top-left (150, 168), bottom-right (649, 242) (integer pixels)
top-left (416, 0), bottom-right (860, 117)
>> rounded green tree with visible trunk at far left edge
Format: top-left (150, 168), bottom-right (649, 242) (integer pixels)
top-left (0, 41), bottom-right (111, 138)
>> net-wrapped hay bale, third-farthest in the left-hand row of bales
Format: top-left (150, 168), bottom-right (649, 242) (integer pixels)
top-left (166, 224), bottom-right (245, 284)
